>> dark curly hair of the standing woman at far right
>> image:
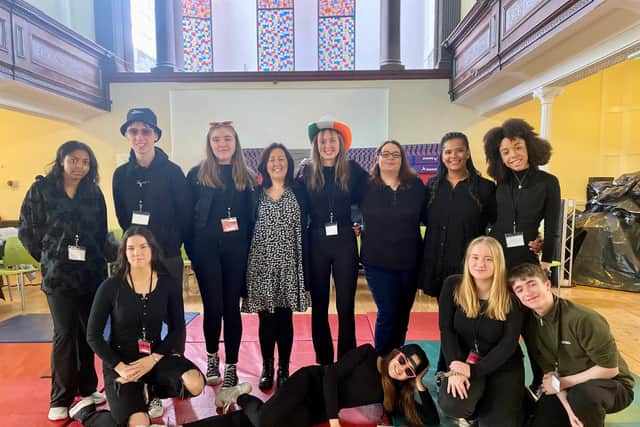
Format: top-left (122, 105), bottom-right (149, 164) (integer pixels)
top-left (483, 119), bottom-right (551, 184)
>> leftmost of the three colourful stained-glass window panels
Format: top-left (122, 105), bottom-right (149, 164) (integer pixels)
top-left (182, 0), bottom-right (213, 72)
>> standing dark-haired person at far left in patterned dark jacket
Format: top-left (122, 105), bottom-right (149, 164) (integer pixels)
top-left (19, 141), bottom-right (107, 421)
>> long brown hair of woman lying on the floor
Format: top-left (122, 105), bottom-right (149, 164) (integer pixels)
top-left (380, 349), bottom-right (423, 427)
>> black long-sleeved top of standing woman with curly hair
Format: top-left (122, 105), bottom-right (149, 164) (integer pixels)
top-left (491, 168), bottom-right (560, 267)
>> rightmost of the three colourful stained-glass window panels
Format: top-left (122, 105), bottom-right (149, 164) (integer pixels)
top-left (318, 0), bottom-right (356, 71)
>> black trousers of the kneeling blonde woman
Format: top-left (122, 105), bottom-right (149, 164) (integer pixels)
top-left (438, 356), bottom-right (524, 427)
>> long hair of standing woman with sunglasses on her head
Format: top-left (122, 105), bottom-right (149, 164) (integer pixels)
top-left (198, 125), bottom-right (256, 191)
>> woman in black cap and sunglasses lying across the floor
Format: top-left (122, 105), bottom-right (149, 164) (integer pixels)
top-left (184, 344), bottom-right (440, 427)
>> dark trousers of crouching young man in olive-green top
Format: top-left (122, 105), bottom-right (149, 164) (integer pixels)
top-left (530, 379), bottom-right (633, 427)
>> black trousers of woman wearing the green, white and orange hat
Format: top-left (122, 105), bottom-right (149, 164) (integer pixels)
top-left (309, 227), bottom-right (358, 365)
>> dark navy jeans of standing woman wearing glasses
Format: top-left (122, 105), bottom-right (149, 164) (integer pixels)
top-left (364, 265), bottom-right (417, 356)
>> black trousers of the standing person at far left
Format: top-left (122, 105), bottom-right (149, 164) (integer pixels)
top-left (47, 293), bottom-right (98, 408)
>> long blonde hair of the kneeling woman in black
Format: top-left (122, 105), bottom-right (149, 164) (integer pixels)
top-left (453, 236), bottom-right (512, 321)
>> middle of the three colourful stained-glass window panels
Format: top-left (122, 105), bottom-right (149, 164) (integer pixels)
top-left (257, 0), bottom-right (295, 72)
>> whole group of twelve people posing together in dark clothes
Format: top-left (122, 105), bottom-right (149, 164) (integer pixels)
top-left (19, 108), bottom-right (633, 427)
